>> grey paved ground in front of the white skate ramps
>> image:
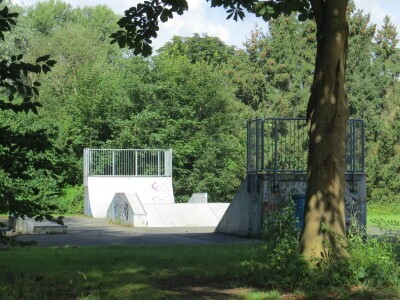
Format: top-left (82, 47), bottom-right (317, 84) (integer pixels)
top-left (18, 217), bottom-right (257, 246)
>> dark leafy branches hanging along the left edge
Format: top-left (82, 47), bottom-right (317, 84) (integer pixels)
top-left (0, 1), bottom-right (62, 227)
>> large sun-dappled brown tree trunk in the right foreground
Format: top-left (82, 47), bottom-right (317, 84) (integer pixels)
top-left (301, 0), bottom-right (349, 259)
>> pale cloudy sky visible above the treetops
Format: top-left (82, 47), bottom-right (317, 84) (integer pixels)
top-left (13, 0), bottom-right (400, 49)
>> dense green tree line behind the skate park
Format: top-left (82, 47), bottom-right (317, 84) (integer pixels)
top-left (0, 1), bottom-right (400, 210)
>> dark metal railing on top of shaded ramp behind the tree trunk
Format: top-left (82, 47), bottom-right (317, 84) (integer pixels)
top-left (247, 118), bottom-right (365, 174)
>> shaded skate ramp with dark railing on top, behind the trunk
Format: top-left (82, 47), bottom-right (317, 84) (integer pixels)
top-left (216, 118), bottom-right (367, 237)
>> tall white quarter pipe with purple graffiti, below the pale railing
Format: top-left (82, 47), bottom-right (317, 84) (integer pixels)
top-left (85, 176), bottom-right (174, 218)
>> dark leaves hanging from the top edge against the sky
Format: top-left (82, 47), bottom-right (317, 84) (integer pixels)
top-left (111, 0), bottom-right (312, 56)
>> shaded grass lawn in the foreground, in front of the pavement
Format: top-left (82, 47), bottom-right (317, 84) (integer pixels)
top-left (0, 244), bottom-right (395, 300)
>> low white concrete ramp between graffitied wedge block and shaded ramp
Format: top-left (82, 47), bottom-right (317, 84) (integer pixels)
top-left (143, 203), bottom-right (229, 227)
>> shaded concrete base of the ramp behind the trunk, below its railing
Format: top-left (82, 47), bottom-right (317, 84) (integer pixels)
top-left (216, 174), bottom-right (367, 237)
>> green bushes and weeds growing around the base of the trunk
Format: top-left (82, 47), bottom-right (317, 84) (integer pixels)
top-left (237, 206), bottom-right (400, 299)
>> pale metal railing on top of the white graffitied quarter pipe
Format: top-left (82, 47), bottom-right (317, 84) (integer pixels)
top-left (83, 148), bottom-right (172, 185)
